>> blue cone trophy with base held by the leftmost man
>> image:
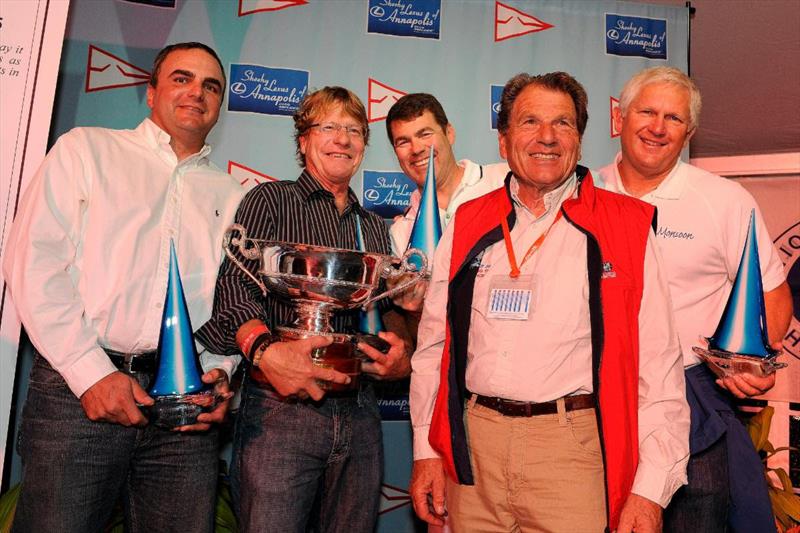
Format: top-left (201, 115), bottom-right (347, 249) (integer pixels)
top-left (148, 240), bottom-right (217, 428)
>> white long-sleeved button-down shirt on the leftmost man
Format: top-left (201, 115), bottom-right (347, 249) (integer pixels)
top-left (3, 119), bottom-right (244, 397)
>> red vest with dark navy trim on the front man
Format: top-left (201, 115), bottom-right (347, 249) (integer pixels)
top-left (428, 166), bottom-right (655, 530)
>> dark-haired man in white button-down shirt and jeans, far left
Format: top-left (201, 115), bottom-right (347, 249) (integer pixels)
top-left (3, 43), bottom-right (242, 533)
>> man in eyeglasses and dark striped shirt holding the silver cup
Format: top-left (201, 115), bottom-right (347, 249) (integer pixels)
top-left (198, 87), bottom-right (411, 533)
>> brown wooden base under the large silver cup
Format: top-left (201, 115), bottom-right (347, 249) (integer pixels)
top-left (277, 327), bottom-right (361, 392)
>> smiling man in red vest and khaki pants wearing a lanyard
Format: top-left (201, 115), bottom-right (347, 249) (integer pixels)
top-left (410, 72), bottom-right (689, 533)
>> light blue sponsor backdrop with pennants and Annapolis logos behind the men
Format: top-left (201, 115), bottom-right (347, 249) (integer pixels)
top-left (3, 0), bottom-right (688, 531)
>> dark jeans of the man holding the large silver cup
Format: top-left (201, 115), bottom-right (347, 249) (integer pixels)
top-left (231, 382), bottom-right (383, 533)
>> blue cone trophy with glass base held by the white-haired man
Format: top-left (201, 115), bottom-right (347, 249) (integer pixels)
top-left (692, 210), bottom-right (786, 377)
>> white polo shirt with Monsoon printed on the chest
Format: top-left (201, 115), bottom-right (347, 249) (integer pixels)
top-left (592, 153), bottom-right (786, 367)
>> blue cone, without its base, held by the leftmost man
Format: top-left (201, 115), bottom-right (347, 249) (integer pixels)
top-left (149, 240), bottom-right (205, 398)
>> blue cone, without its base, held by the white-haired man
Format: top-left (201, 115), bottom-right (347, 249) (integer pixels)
top-left (708, 210), bottom-right (775, 357)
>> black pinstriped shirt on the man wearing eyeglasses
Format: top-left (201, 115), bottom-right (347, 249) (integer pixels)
top-left (196, 170), bottom-right (391, 354)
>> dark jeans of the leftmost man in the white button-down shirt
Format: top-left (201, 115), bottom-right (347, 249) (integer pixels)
top-left (12, 354), bottom-right (219, 533)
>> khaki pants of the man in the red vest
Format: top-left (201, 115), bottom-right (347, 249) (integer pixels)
top-left (447, 400), bottom-right (606, 533)
